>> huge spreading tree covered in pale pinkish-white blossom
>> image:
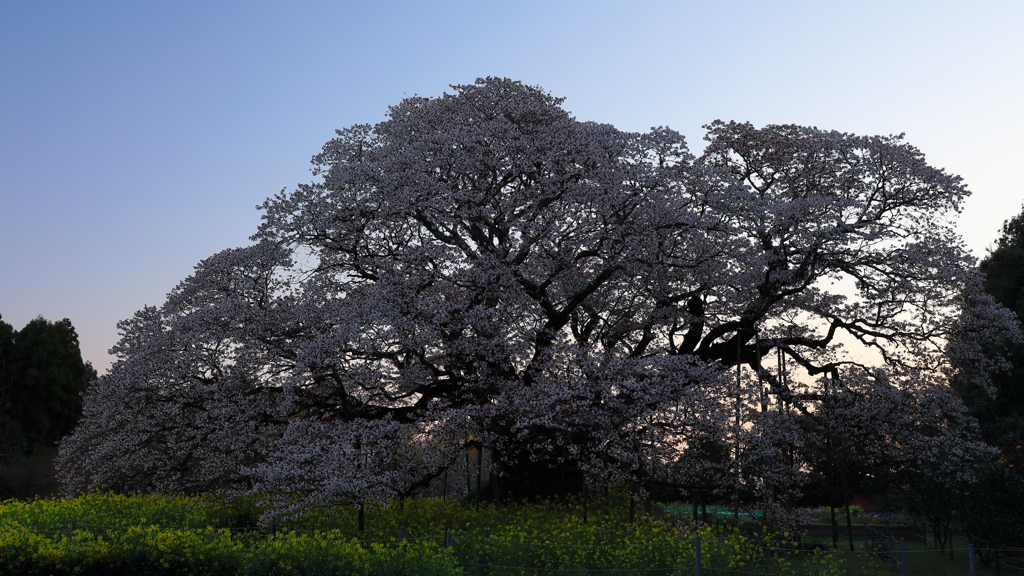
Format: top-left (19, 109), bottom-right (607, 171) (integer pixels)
top-left (59, 78), bottom-right (1012, 516)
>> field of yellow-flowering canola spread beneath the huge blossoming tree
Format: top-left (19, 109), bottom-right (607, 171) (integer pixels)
top-left (0, 493), bottom-right (836, 576)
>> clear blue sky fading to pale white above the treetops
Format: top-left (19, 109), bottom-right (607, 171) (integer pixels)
top-left (0, 0), bottom-right (1024, 372)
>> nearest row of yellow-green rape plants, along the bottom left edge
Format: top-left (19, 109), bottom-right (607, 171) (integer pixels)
top-left (0, 524), bottom-right (461, 576)
